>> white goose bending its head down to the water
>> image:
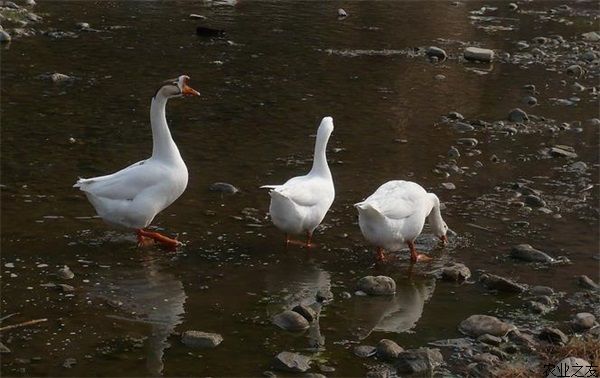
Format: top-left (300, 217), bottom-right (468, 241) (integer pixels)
top-left (354, 180), bottom-right (448, 263)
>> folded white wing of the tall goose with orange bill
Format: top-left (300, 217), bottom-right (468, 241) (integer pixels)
top-left (73, 160), bottom-right (166, 200)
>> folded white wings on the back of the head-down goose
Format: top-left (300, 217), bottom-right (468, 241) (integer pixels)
top-left (364, 181), bottom-right (427, 219)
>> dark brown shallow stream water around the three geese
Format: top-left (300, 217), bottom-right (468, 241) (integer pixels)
top-left (1, 0), bottom-right (599, 376)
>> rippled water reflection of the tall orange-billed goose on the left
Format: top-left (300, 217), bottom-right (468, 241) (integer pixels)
top-left (89, 258), bottom-right (187, 375)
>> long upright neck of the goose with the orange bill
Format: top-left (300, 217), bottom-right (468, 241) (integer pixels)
top-left (150, 94), bottom-right (179, 159)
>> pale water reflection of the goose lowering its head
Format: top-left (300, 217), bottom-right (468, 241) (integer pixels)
top-left (352, 279), bottom-right (435, 340)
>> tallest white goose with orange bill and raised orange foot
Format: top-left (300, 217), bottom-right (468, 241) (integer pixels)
top-left (73, 75), bottom-right (200, 248)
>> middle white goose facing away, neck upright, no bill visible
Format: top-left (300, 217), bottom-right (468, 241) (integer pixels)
top-left (261, 117), bottom-right (335, 248)
